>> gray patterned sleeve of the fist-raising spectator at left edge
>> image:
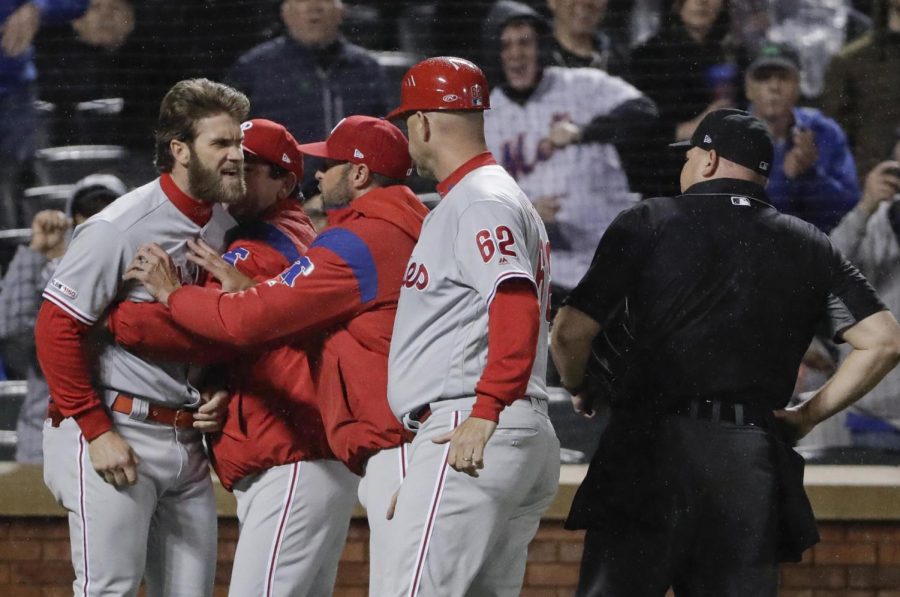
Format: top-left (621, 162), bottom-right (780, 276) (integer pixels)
top-left (0, 245), bottom-right (48, 340)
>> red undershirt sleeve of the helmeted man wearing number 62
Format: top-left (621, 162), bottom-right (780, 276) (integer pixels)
top-left (472, 278), bottom-right (541, 422)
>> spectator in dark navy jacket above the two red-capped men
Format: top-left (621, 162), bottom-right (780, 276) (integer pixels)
top-left (226, 0), bottom-right (387, 194)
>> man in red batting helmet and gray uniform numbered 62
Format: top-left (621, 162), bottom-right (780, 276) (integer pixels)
top-left (382, 57), bottom-right (559, 597)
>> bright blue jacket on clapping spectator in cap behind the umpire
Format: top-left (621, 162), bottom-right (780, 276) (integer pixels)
top-left (766, 108), bottom-right (860, 233)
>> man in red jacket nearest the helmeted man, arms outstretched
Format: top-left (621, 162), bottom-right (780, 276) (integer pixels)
top-left (118, 116), bottom-right (428, 594)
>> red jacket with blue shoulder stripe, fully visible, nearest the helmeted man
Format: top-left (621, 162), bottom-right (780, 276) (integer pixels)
top-left (159, 185), bottom-right (428, 472)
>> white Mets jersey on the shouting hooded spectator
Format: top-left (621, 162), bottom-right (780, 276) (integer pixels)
top-left (484, 67), bottom-right (641, 288)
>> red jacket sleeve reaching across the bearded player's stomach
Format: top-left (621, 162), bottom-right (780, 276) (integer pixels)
top-left (106, 301), bottom-right (240, 365)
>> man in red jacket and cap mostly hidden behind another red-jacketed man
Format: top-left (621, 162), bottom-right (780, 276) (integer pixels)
top-left (109, 119), bottom-right (359, 597)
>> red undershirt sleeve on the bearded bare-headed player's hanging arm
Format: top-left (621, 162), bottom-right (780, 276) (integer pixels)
top-left (35, 301), bottom-right (112, 441)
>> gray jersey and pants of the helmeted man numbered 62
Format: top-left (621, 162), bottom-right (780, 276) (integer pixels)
top-left (382, 158), bottom-right (559, 596)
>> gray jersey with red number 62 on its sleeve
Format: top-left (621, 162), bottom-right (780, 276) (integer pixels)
top-left (388, 154), bottom-right (550, 419)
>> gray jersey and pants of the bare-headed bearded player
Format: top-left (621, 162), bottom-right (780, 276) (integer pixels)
top-left (38, 175), bottom-right (234, 597)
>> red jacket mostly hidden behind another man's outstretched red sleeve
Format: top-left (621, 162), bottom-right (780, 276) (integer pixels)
top-left (109, 199), bottom-right (333, 489)
